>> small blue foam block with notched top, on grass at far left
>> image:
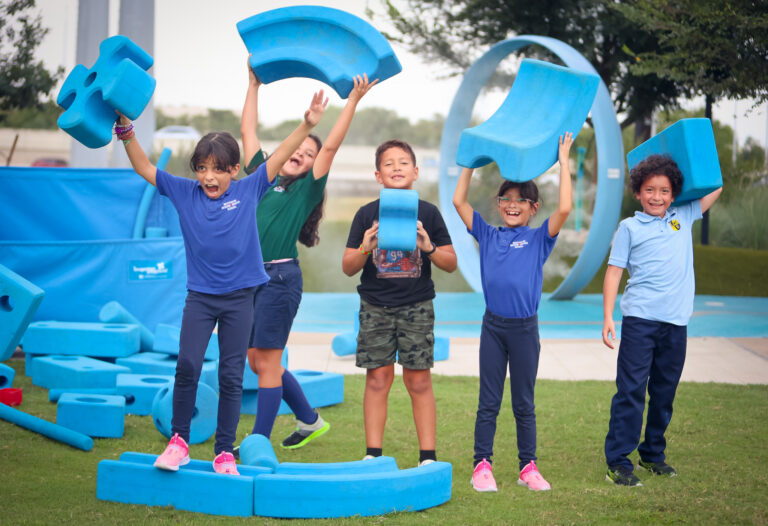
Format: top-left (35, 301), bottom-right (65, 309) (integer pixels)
top-left (56, 393), bottom-right (125, 438)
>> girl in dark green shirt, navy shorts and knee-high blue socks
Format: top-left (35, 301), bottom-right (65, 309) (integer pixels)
top-left (241, 68), bottom-right (378, 449)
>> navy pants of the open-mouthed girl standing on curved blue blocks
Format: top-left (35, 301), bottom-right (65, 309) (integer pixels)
top-left (171, 287), bottom-right (256, 455)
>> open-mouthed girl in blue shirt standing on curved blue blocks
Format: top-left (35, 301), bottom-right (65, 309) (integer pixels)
top-left (116, 91), bottom-right (328, 475)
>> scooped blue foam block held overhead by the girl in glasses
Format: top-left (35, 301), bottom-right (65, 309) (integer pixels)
top-left (456, 59), bottom-right (600, 182)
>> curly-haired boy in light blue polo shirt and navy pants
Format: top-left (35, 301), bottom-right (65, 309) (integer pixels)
top-left (603, 155), bottom-right (722, 486)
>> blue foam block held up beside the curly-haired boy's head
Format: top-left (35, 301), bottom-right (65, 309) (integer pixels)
top-left (627, 119), bottom-right (723, 204)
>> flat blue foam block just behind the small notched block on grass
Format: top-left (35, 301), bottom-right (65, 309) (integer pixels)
top-left (32, 355), bottom-right (130, 389)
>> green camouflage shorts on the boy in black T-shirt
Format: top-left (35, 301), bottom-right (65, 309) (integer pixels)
top-left (356, 300), bottom-right (435, 369)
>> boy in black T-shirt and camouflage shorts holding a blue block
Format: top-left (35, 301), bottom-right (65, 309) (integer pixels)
top-left (341, 140), bottom-right (456, 466)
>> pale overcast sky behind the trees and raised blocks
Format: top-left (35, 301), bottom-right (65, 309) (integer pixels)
top-left (37, 0), bottom-right (768, 146)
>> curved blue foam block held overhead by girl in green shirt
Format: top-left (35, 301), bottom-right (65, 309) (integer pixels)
top-left (237, 6), bottom-right (403, 99)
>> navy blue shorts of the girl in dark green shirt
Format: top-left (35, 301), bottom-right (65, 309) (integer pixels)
top-left (251, 259), bottom-right (304, 349)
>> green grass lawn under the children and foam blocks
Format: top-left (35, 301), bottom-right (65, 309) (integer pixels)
top-left (0, 360), bottom-right (768, 525)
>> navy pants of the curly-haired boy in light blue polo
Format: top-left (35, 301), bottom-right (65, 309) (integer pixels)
top-left (605, 316), bottom-right (688, 469)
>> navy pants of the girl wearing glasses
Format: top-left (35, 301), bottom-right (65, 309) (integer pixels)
top-left (475, 310), bottom-right (541, 469)
